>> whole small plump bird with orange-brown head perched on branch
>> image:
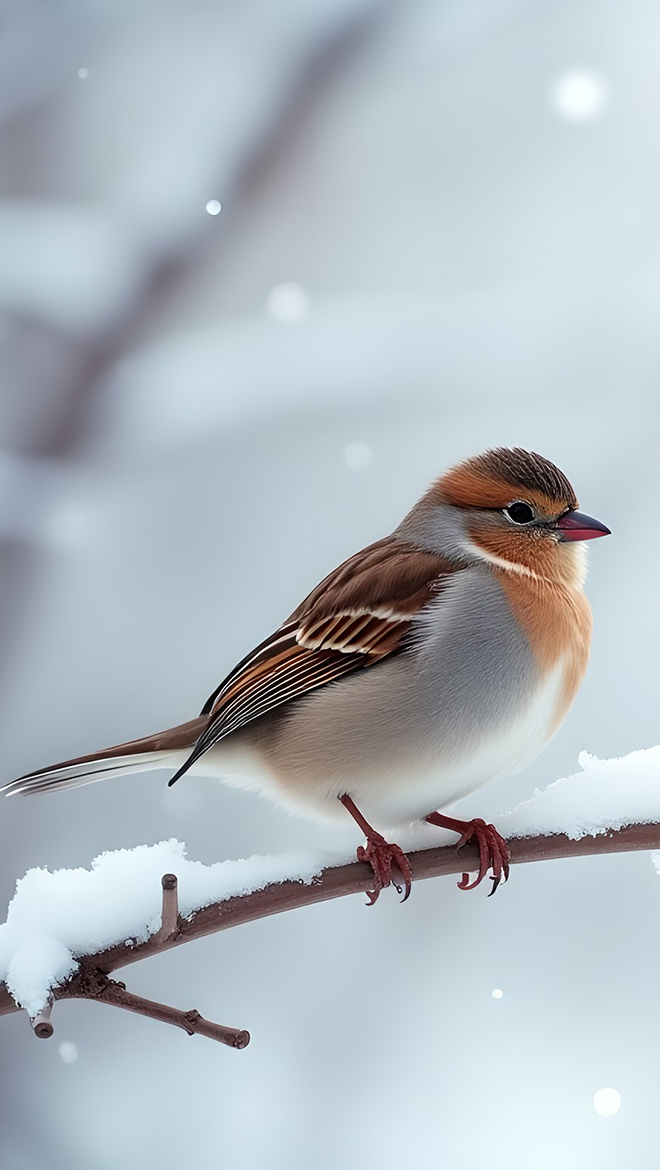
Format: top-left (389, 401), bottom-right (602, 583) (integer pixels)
top-left (4, 447), bottom-right (610, 904)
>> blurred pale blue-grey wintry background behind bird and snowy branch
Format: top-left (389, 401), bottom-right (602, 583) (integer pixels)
top-left (0, 0), bottom-right (660, 1170)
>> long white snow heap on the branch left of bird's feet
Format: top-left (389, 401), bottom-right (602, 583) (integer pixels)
top-left (0, 839), bottom-right (323, 1016)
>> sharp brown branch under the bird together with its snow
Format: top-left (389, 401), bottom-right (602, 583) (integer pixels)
top-left (0, 748), bottom-right (660, 1048)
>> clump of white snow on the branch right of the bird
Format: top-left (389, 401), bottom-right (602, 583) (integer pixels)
top-left (496, 746), bottom-right (660, 841)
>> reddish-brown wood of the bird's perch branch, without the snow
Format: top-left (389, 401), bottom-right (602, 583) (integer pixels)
top-left (0, 824), bottom-right (660, 1048)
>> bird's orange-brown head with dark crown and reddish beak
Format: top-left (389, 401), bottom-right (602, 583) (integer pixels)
top-left (401, 447), bottom-right (610, 584)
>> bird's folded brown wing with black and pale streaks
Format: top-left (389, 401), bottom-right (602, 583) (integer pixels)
top-left (170, 536), bottom-right (455, 784)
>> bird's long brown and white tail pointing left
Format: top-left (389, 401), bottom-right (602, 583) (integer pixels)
top-left (0, 715), bottom-right (208, 797)
